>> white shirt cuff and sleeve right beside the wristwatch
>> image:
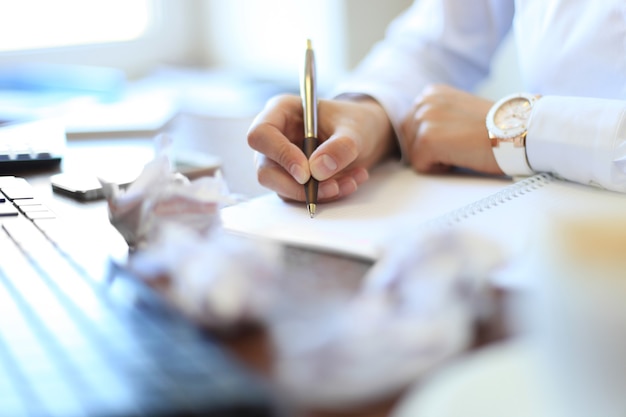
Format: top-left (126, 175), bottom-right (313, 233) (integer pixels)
top-left (526, 96), bottom-right (626, 192)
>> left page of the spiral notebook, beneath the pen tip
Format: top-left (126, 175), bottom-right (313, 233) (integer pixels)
top-left (222, 162), bottom-right (512, 260)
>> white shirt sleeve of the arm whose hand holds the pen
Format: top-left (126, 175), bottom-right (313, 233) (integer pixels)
top-left (333, 0), bottom-right (514, 143)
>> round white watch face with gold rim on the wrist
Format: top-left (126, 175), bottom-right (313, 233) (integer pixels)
top-left (488, 95), bottom-right (534, 139)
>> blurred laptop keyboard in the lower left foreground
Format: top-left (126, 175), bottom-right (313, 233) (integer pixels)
top-left (0, 177), bottom-right (276, 417)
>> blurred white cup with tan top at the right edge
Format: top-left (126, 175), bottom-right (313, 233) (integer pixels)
top-left (525, 212), bottom-right (626, 417)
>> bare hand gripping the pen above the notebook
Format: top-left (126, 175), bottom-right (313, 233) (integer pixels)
top-left (248, 48), bottom-right (396, 205)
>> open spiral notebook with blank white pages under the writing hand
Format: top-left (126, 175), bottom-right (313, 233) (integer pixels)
top-left (222, 158), bottom-right (626, 261)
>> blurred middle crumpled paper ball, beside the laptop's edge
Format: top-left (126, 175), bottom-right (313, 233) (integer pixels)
top-left (129, 224), bottom-right (282, 330)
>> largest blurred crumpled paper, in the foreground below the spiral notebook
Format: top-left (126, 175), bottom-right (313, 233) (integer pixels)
top-left (270, 230), bottom-right (503, 409)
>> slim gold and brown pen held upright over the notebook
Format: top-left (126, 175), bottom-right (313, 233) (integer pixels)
top-left (300, 39), bottom-right (319, 218)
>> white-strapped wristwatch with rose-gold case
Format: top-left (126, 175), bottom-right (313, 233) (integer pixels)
top-left (487, 93), bottom-right (539, 176)
